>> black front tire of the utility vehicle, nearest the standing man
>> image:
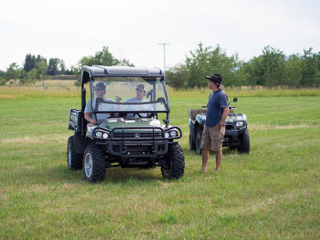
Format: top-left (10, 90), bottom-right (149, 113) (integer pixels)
top-left (161, 144), bottom-right (185, 179)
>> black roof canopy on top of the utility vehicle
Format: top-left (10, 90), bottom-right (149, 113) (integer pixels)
top-left (81, 65), bottom-right (165, 87)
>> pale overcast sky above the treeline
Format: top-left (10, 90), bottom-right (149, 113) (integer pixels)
top-left (0, 0), bottom-right (320, 71)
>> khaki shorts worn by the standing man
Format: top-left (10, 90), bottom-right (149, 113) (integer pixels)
top-left (201, 125), bottom-right (226, 151)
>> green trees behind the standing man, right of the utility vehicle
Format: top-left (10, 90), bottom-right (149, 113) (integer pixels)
top-left (166, 43), bottom-right (320, 89)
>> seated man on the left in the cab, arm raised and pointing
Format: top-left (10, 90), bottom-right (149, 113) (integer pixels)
top-left (84, 82), bottom-right (121, 127)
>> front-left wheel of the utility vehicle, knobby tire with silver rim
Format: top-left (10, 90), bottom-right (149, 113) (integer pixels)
top-left (83, 145), bottom-right (106, 182)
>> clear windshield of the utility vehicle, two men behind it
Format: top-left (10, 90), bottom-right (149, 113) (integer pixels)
top-left (87, 77), bottom-right (169, 121)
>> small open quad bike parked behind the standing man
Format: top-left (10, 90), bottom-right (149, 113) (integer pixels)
top-left (188, 98), bottom-right (250, 154)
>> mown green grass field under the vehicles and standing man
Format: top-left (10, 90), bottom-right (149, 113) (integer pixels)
top-left (0, 85), bottom-right (320, 239)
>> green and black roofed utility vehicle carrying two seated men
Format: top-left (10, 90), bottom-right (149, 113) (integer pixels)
top-left (67, 66), bottom-right (185, 182)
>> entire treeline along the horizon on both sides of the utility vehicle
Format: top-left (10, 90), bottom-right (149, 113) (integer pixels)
top-left (0, 43), bottom-right (320, 89)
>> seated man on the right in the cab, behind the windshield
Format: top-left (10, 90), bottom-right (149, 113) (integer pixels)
top-left (124, 84), bottom-right (152, 117)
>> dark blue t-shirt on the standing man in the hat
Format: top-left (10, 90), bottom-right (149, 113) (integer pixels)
top-left (206, 89), bottom-right (229, 127)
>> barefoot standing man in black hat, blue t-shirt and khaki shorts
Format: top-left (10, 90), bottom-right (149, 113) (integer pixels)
top-left (200, 74), bottom-right (229, 172)
